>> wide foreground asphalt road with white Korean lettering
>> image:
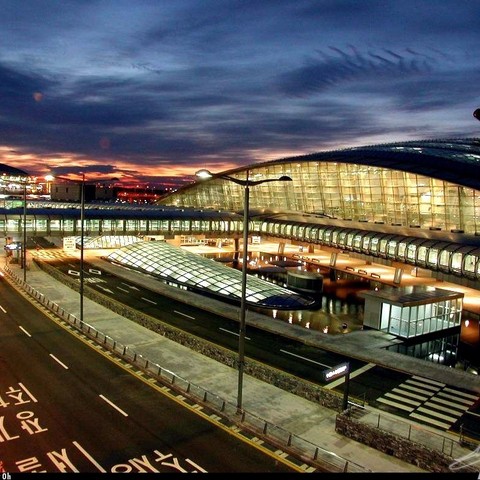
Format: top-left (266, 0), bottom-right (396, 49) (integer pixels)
top-left (0, 281), bottom-right (297, 473)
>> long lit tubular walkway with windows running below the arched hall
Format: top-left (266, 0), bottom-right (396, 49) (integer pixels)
top-left (4, 202), bottom-right (480, 288)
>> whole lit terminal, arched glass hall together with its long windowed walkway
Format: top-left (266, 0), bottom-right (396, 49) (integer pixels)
top-left (0, 139), bottom-right (480, 290)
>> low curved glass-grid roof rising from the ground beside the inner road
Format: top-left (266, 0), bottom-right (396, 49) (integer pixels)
top-left (107, 241), bottom-right (315, 310)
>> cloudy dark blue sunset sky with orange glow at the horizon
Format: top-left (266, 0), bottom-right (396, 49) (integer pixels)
top-left (0, 0), bottom-right (480, 186)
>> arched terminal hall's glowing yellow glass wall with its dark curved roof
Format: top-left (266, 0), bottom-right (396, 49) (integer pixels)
top-left (161, 142), bottom-right (480, 234)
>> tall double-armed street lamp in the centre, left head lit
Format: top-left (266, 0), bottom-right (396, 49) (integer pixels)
top-left (195, 169), bottom-right (292, 412)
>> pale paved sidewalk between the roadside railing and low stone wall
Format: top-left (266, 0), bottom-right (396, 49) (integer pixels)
top-left (1, 255), bottom-right (430, 473)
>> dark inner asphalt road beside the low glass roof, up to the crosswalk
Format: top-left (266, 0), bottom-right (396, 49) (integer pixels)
top-left (61, 261), bottom-right (408, 392)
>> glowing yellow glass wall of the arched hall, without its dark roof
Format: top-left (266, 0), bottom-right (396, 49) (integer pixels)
top-left (160, 147), bottom-right (480, 234)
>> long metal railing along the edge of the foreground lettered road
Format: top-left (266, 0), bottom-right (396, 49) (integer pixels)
top-left (4, 265), bottom-right (371, 473)
